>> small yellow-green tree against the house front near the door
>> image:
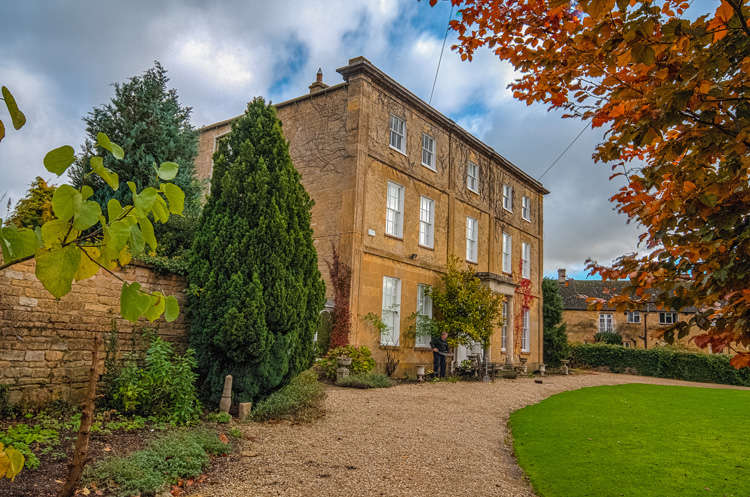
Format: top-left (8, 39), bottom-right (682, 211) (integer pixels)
top-left (430, 256), bottom-right (503, 347)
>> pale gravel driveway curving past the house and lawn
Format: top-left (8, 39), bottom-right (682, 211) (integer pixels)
top-left (188, 373), bottom-right (750, 497)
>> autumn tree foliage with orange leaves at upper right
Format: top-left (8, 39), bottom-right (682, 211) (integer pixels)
top-left (430, 0), bottom-right (750, 368)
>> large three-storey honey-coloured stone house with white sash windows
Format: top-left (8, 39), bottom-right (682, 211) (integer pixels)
top-left (196, 57), bottom-right (548, 372)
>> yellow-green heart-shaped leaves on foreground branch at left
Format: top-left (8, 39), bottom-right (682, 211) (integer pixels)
top-left (0, 126), bottom-right (185, 322)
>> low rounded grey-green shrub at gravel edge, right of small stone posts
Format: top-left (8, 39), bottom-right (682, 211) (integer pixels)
top-left (250, 369), bottom-right (325, 421)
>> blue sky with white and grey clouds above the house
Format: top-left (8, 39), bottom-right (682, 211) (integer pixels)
top-left (0, 0), bottom-right (648, 277)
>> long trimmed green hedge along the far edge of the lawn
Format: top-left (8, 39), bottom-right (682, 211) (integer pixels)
top-left (570, 344), bottom-right (750, 386)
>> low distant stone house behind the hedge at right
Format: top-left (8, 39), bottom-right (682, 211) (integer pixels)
top-left (558, 269), bottom-right (724, 352)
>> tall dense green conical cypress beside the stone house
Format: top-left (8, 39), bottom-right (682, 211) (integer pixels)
top-left (188, 98), bottom-right (325, 404)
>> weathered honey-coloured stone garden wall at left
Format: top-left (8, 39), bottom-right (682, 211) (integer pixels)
top-left (0, 260), bottom-right (187, 404)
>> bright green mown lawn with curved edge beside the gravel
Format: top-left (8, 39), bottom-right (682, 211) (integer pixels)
top-left (510, 384), bottom-right (750, 497)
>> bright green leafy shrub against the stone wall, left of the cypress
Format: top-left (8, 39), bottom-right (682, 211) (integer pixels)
top-left (112, 336), bottom-right (201, 425)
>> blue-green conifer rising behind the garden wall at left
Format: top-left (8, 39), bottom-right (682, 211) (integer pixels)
top-left (68, 62), bottom-right (202, 255)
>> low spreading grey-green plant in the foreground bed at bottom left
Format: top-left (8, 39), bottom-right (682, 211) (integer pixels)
top-left (85, 429), bottom-right (230, 497)
